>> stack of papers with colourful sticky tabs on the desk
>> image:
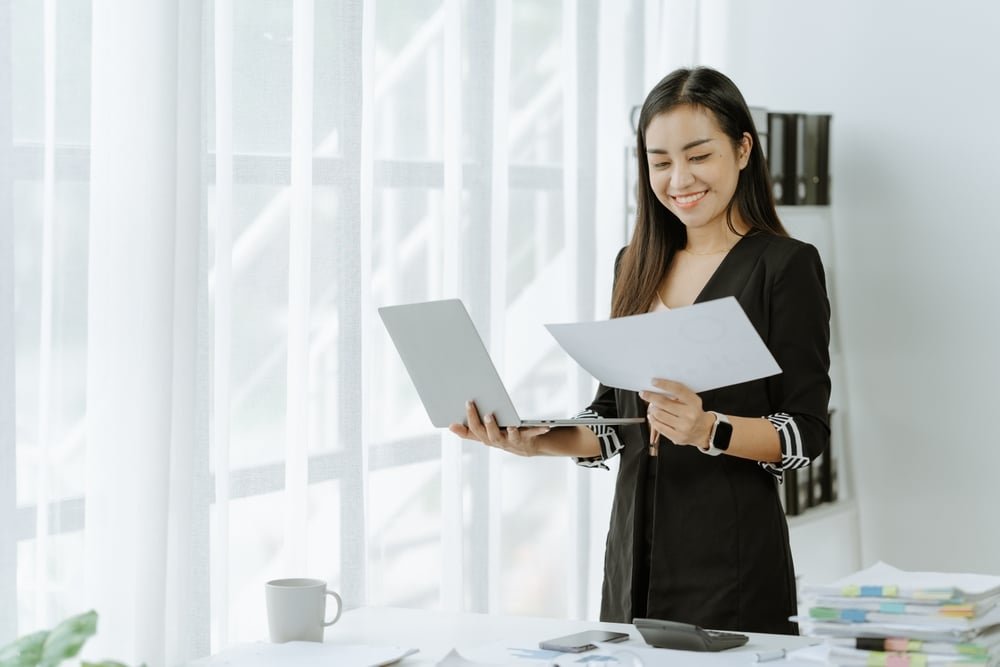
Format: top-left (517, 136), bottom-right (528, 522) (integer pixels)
top-left (795, 563), bottom-right (1000, 667)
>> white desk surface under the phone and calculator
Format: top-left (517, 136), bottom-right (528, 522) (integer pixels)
top-left (325, 607), bottom-right (817, 667)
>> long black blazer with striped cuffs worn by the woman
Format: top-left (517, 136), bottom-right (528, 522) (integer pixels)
top-left (589, 233), bottom-right (830, 634)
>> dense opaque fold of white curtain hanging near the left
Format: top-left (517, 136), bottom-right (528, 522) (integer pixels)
top-left (83, 1), bottom-right (206, 663)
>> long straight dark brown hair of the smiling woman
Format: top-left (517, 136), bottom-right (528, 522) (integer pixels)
top-left (611, 67), bottom-right (788, 317)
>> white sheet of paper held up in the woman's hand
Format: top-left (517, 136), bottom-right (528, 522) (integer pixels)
top-left (545, 297), bottom-right (781, 392)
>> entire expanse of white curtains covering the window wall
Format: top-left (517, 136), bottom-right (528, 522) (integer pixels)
top-left (0, 0), bottom-right (649, 665)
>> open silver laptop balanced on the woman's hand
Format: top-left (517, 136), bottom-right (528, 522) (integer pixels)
top-left (378, 299), bottom-right (644, 428)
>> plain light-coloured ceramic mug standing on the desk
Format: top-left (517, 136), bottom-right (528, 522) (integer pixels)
top-left (264, 579), bottom-right (343, 642)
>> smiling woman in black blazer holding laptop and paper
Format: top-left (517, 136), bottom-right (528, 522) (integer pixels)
top-left (451, 68), bottom-right (830, 634)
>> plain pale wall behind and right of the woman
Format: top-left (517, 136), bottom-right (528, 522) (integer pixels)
top-left (698, 0), bottom-right (1000, 574)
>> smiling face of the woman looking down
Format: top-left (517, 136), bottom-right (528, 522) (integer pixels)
top-left (645, 105), bottom-right (751, 229)
